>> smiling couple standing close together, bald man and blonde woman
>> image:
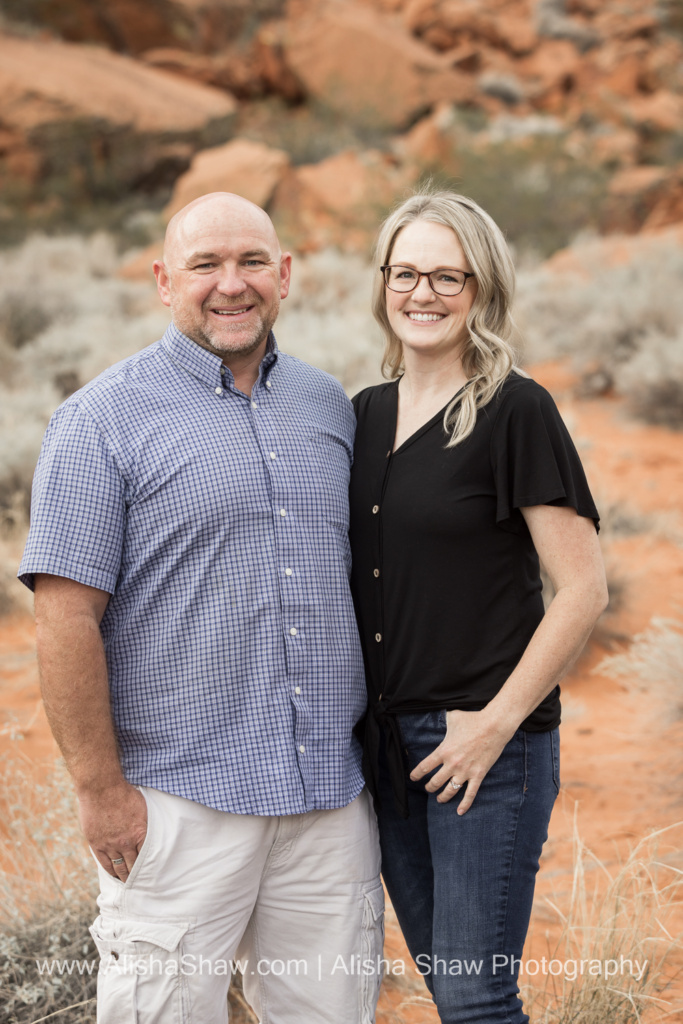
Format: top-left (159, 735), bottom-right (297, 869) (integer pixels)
top-left (19, 193), bottom-right (606, 1024)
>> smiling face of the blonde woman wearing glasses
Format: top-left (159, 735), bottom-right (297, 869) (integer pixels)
top-left (385, 220), bottom-right (477, 364)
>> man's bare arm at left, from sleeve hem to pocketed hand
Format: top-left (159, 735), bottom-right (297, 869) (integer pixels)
top-left (35, 573), bottom-right (147, 882)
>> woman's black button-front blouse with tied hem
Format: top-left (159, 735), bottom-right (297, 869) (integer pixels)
top-left (350, 374), bottom-right (598, 815)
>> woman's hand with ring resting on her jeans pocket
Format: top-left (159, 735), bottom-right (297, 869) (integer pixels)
top-left (411, 710), bottom-right (514, 814)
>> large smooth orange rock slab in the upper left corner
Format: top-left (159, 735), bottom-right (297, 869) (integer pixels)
top-left (0, 35), bottom-right (237, 196)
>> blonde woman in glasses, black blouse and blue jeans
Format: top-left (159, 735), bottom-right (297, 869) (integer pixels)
top-left (351, 191), bottom-right (607, 1024)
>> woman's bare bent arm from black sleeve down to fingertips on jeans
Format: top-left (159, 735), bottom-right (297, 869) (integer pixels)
top-left (411, 505), bottom-right (607, 814)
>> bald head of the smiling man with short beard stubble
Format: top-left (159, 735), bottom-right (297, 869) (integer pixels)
top-left (155, 193), bottom-right (292, 365)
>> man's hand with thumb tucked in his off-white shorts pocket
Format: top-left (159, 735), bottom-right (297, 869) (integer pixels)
top-left (78, 780), bottom-right (147, 882)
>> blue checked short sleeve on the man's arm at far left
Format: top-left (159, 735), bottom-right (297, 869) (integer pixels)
top-left (18, 402), bottom-right (126, 594)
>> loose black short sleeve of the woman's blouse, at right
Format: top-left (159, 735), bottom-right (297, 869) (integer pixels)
top-left (490, 378), bottom-right (599, 531)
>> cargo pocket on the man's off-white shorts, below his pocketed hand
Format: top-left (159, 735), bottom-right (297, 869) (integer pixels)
top-left (90, 915), bottom-right (190, 1024)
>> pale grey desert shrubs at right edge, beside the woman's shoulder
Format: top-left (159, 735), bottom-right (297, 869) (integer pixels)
top-left (517, 238), bottom-right (683, 429)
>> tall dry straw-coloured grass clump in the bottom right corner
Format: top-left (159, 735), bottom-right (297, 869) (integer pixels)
top-left (520, 819), bottom-right (683, 1024)
